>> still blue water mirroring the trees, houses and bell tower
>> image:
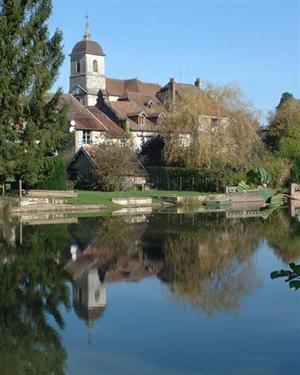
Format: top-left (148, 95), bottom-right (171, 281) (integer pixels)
top-left (0, 211), bottom-right (300, 375)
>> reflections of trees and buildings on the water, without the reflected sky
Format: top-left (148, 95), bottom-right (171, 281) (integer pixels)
top-left (0, 211), bottom-right (300, 374)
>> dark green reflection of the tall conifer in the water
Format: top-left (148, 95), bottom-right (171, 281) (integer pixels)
top-left (0, 226), bottom-right (69, 375)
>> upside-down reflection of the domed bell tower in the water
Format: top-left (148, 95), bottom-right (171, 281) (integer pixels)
top-left (73, 269), bottom-right (106, 328)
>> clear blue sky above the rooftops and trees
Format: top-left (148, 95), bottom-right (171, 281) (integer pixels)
top-left (50, 0), bottom-right (300, 121)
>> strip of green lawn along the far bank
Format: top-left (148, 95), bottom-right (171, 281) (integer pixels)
top-left (69, 190), bottom-right (203, 209)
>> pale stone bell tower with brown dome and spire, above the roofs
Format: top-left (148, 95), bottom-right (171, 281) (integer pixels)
top-left (70, 17), bottom-right (105, 106)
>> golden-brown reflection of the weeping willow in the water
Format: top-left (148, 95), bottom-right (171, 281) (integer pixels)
top-left (161, 222), bottom-right (259, 314)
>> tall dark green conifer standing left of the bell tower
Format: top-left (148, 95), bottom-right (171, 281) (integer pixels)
top-left (0, 0), bottom-right (68, 186)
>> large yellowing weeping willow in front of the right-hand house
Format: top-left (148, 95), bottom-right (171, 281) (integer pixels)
top-left (163, 85), bottom-right (259, 171)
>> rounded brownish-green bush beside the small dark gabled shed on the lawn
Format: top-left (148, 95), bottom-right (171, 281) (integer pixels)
top-left (93, 145), bottom-right (139, 191)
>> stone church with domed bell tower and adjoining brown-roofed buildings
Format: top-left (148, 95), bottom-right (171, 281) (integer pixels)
top-left (65, 24), bottom-right (213, 152)
